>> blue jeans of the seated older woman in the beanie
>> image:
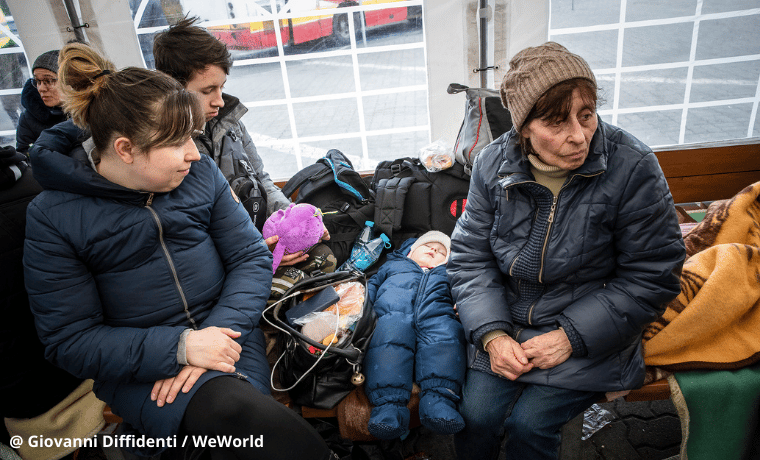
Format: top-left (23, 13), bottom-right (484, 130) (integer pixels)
top-left (454, 369), bottom-right (601, 460)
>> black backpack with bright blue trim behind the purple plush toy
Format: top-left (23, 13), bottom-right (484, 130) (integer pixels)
top-left (282, 149), bottom-right (375, 266)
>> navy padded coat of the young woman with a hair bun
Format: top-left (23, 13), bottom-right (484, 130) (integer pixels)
top-left (24, 122), bottom-right (272, 455)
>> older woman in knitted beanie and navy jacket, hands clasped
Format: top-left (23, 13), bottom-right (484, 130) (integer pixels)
top-left (448, 42), bottom-right (685, 460)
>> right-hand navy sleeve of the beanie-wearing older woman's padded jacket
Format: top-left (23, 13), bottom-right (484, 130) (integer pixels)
top-left (563, 146), bottom-right (686, 358)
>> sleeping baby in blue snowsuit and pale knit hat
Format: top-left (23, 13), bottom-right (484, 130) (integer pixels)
top-left (364, 231), bottom-right (466, 439)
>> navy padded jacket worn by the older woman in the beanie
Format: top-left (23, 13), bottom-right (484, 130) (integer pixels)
top-left (448, 120), bottom-right (685, 391)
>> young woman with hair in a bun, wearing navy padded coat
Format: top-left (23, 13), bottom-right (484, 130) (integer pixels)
top-left (24, 44), bottom-right (332, 459)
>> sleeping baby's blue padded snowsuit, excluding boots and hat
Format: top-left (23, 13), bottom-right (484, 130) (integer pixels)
top-left (364, 238), bottom-right (466, 405)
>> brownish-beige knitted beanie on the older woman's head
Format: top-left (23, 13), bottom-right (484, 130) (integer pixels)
top-left (500, 42), bottom-right (596, 132)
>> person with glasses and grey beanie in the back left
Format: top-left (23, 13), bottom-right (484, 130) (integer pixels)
top-left (16, 50), bottom-right (66, 154)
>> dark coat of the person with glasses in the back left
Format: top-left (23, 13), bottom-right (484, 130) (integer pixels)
top-left (16, 78), bottom-right (66, 153)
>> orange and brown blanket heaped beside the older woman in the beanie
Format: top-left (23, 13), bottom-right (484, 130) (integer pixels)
top-left (644, 182), bottom-right (760, 372)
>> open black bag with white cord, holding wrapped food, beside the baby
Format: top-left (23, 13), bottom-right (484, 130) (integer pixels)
top-left (264, 271), bottom-right (377, 409)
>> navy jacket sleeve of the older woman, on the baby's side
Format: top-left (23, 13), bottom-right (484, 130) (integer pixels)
top-left (446, 149), bottom-right (512, 348)
